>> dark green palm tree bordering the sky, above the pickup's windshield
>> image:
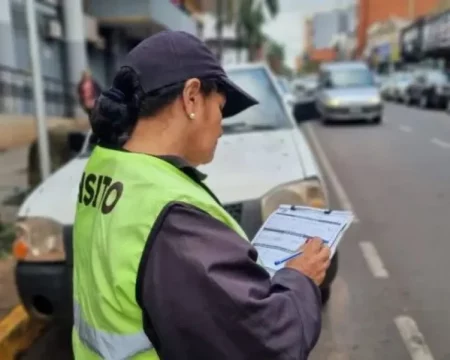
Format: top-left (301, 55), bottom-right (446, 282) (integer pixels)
top-left (236, 0), bottom-right (279, 61)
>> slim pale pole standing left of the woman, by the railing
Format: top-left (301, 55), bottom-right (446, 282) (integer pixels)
top-left (26, 0), bottom-right (50, 180)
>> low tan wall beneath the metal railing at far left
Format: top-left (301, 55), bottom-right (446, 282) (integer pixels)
top-left (0, 114), bottom-right (89, 151)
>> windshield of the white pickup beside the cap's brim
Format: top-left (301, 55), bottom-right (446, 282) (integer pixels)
top-left (222, 68), bottom-right (293, 134)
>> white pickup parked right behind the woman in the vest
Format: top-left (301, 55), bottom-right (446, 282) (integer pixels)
top-left (14, 64), bottom-right (338, 322)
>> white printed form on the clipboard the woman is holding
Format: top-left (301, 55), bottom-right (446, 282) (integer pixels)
top-left (252, 205), bottom-right (353, 276)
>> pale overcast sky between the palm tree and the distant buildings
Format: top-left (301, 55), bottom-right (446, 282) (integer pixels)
top-left (264, 0), bottom-right (351, 68)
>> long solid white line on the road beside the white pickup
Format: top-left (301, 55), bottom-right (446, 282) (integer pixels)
top-left (305, 124), bottom-right (359, 223)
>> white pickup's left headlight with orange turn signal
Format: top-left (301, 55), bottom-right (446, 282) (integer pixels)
top-left (13, 217), bottom-right (66, 261)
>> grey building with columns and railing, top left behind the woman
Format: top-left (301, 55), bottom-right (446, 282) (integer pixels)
top-left (0, 0), bottom-right (201, 116)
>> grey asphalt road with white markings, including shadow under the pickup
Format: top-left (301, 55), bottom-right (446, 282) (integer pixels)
top-left (24, 104), bottom-right (450, 360)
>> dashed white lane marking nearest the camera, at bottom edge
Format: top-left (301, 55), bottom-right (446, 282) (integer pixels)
top-left (394, 315), bottom-right (434, 360)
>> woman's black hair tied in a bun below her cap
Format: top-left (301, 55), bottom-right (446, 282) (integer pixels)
top-left (90, 67), bottom-right (220, 146)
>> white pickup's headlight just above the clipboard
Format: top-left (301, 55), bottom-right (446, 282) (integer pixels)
top-left (261, 178), bottom-right (328, 221)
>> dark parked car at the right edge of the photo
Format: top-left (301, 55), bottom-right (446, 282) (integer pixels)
top-left (405, 69), bottom-right (450, 109)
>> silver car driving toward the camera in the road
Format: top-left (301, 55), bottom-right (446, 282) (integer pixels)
top-left (316, 61), bottom-right (383, 124)
